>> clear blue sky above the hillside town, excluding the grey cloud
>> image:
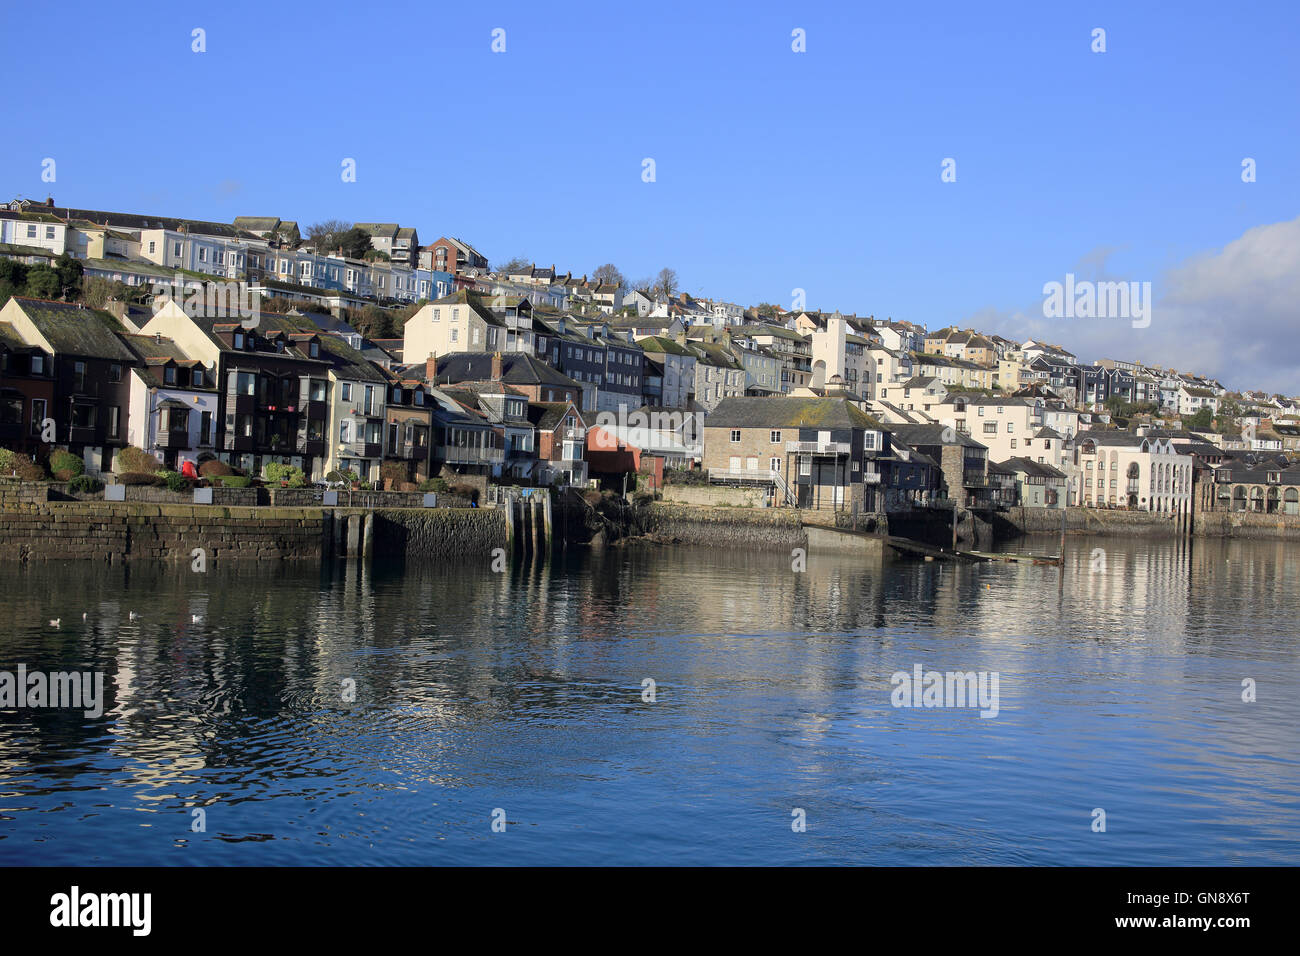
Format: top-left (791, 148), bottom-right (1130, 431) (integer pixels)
top-left (0, 1), bottom-right (1300, 388)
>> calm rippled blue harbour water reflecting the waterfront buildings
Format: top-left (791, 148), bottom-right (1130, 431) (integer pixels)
top-left (0, 538), bottom-right (1300, 865)
